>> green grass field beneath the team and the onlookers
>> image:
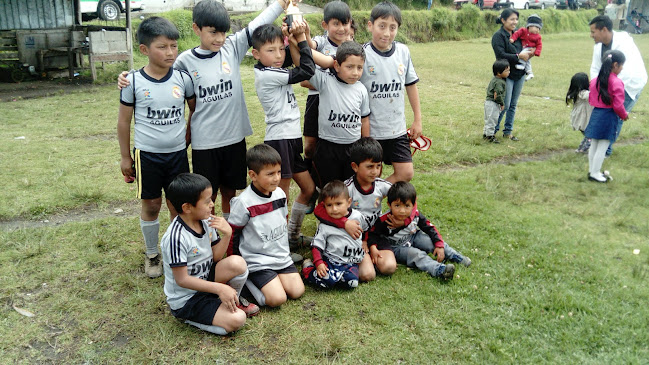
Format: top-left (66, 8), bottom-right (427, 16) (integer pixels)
top-left (0, 33), bottom-right (649, 364)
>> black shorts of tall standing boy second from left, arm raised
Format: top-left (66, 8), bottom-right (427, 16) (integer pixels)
top-left (192, 139), bottom-right (248, 193)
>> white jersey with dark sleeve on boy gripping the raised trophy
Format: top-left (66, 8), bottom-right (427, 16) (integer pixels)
top-left (255, 42), bottom-right (315, 141)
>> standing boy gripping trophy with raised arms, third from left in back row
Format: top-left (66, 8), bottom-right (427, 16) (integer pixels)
top-left (252, 22), bottom-right (315, 249)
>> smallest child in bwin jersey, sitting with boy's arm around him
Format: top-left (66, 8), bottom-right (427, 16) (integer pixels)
top-left (302, 180), bottom-right (368, 289)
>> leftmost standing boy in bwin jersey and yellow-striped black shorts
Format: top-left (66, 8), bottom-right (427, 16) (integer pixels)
top-left (117, 17), bottom-right (196, 278)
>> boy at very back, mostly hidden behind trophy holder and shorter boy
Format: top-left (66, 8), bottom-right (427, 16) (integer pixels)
top-left (300, 0), bottom-right (352, 163)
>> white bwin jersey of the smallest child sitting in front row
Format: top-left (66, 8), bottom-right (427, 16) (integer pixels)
top-left (311, 209), bottom-right (369, 265)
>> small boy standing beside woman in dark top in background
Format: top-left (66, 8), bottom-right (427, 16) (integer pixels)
top-left (482, 59), bottom-right (509, 143)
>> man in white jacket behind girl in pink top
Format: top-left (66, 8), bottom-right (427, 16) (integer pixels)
top-left (589, 15), bottom-right (647, 156)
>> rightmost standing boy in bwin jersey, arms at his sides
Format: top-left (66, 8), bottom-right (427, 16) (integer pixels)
top-left (361, 1), bottom-right (422, 184)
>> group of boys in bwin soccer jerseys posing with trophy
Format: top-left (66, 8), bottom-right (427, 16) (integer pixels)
top-left (118, 0), bottom-right (471, 334)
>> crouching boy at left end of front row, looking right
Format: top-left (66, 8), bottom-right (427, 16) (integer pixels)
top-left (161, 173), bottom-right (259, 335)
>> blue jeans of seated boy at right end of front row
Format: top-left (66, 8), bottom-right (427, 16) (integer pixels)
top-left (390, 231), bottom-right (464, 276)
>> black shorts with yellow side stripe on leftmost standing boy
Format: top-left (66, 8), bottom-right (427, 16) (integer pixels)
top-left (133, 148), bottom-right (189, 199)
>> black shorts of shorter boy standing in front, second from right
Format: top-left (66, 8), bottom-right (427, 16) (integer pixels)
top-left (312, 139), bottom-right (354, 189)
